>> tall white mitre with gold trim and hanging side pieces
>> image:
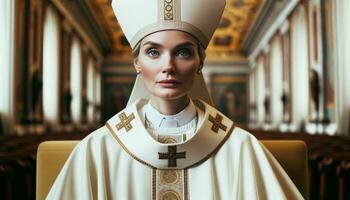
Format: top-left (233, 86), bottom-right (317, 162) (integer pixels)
top-left (112, 0), bottom-right (226, 105)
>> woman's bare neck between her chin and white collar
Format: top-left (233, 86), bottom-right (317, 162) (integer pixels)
top-left (150, 95), bottom-right (190, 115)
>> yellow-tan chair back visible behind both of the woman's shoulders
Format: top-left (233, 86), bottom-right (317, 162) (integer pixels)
top-left (36, 140), bottom-right (308, 200)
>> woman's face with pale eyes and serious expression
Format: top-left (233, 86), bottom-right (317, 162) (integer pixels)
top-left (134, 31), bottom-right (201, 100)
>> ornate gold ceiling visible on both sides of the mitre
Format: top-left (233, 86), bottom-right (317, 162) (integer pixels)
top-left (89, 0), bottom-right (264, 58)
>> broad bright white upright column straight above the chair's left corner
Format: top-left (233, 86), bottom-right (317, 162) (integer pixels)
top-left (43, 6), bottom-right (60, 124)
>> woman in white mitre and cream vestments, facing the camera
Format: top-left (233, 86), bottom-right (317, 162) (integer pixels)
top-left (48, 0), bottom-right (302, 200)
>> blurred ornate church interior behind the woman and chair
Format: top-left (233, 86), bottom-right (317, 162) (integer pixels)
top-left (0, 0), bottom-right (350, 199)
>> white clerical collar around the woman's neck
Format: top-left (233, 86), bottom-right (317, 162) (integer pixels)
top-left (144, 100), bottom-right (197, 128)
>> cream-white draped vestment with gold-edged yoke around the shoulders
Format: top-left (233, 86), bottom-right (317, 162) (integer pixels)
top-left (47, 100), bottom-right (303, 200)
